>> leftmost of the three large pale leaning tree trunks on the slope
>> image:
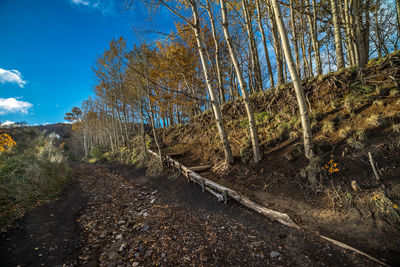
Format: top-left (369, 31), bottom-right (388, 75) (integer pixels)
top-left (191, 2), bottom-right (233, 164)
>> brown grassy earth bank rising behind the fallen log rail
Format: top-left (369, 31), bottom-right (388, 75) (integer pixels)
top-left (160, 52), bottom-right (400, 264)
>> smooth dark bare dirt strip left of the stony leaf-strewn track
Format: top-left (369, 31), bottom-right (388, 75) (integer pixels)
top-left (0, 182), bottom-right (87, 266)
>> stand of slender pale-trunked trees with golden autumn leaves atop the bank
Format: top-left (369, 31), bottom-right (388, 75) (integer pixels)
top-left (66, 0), bottom-right (399, 164)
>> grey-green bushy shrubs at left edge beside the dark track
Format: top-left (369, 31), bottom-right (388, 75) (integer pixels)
top-left (0, 129), bottom-right (71, 230)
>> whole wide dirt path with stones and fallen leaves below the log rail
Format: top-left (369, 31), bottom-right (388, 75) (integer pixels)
top-left (0, 165), bottom-right (384, 266)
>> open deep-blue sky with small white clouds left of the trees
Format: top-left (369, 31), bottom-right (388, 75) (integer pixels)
top-left (0, 0), bottom-right (174, 125)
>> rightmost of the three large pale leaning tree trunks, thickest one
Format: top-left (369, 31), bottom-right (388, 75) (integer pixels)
top-left (271, 0), bottom-right (313, 159)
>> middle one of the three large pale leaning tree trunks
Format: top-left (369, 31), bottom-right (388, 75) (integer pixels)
top-left (220, 0), bottom-right (261, 162)
